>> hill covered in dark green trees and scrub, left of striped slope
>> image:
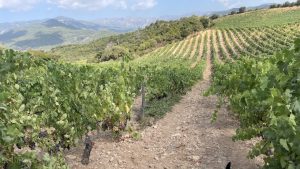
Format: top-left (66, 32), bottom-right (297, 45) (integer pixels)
top-left (51, 16), bottom-right (210, 62)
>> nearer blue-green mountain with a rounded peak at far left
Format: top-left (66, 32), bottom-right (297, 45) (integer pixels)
top-left (0, 17), bottom-right (116, 50)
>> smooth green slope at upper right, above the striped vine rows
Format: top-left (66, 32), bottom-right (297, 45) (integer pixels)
top-left (214, 7), bottom-right (300, 28)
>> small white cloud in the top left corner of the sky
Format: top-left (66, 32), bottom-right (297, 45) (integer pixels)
top-left (0, 0), bottom-right (40, 11)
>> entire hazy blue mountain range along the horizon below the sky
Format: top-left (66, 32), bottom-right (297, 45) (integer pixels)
top-left (0, 4), bottom-right (271, 50)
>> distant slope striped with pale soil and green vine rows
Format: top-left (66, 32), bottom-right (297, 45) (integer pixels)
top-left (137, 23), bottom-right (300, 66)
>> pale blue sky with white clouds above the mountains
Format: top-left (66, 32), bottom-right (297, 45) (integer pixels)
top-left (0, 0), bottom-right (296, 22)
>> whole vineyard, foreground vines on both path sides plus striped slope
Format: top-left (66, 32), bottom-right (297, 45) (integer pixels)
top-left (0, 5), bottom-right (300, 169)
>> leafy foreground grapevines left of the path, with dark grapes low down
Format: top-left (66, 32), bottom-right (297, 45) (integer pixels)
top-left (0, 50), bottom-right (134, 168)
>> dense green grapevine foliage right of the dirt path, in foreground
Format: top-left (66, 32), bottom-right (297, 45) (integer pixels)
top-left (212, 40), bottom-right (300, 169)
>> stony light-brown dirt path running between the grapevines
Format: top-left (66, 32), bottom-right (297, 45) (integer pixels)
top-left (67, 52), bottom-right (257, 169)
